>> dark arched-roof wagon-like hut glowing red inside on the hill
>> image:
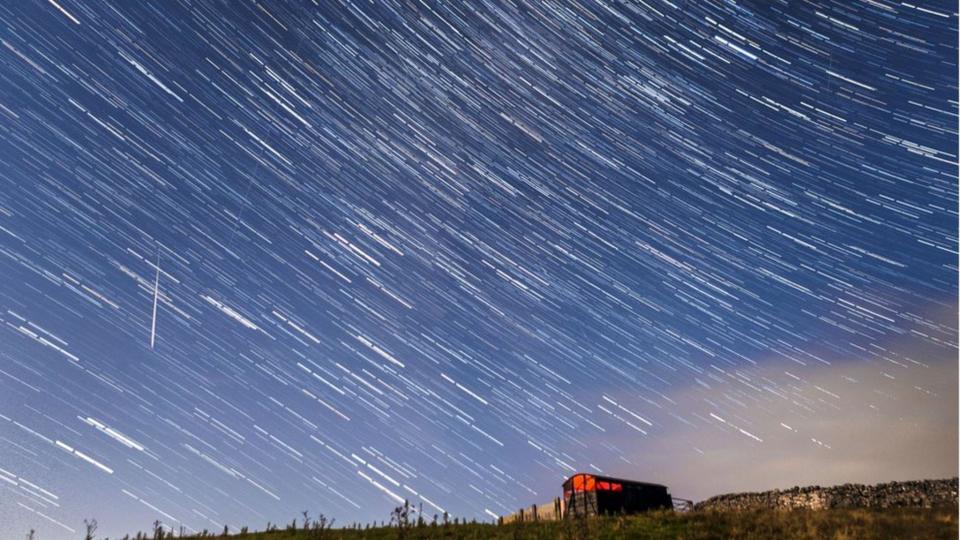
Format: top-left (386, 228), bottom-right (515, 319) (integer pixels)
top-left (563, 473), bottom-right (673, 517)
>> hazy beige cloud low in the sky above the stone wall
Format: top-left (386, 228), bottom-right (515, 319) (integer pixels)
top-left (588, 304), bottom-right (958, 500)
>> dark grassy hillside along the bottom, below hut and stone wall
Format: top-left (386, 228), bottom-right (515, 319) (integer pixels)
top-left (163, 507), bottom-right (958, 540)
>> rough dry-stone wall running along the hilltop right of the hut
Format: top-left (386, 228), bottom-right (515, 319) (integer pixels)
top-left (694, 478), bottom-right (957, 510)
